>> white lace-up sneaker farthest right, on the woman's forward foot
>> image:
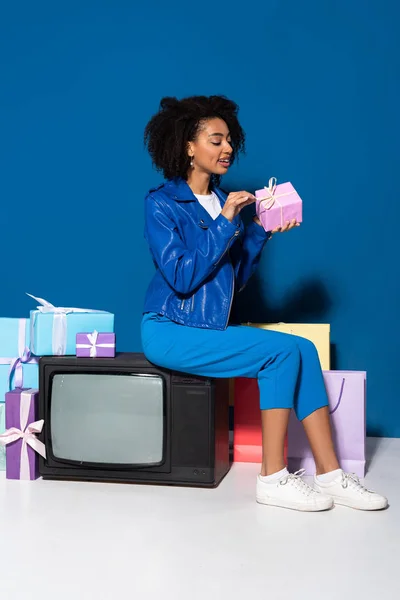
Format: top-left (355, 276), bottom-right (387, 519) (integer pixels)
top-left (314, 471), bottom-right (388, 510)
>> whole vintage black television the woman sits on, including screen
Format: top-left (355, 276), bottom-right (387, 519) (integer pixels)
top-left (39, 353), bottom-right (230, 487)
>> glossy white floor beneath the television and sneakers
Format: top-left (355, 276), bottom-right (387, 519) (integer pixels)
top-left (0, 438), bottom-right (400, 600)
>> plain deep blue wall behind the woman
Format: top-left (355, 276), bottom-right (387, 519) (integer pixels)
top-left (0, 0), bottom-right (400, 436)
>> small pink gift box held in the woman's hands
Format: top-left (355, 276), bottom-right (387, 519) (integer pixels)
top-left (255, 177), bottom-right (303, 231)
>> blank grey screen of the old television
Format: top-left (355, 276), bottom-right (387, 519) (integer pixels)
top-left (50, 373), bottom-right (165, 466)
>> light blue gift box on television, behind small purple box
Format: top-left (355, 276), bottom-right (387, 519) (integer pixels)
top-left (30, 296), bottom-right (114, 356)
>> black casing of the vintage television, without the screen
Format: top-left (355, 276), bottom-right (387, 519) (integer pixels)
top-left (39, 353), bottom-right (230, 487)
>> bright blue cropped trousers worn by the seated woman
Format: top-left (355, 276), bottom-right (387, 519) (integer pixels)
top-left (141, 313), bottom-right (328, 420)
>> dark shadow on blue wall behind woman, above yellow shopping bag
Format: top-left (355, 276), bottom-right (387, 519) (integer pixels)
top-left (236, 273), bottom-right (338, 370)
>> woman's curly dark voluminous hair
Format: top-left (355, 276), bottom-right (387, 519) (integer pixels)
top-left (144, 96), bottom-right (245, 185)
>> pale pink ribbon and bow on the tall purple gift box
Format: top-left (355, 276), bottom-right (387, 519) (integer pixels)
top-left (0, 390), bottom-right (46, 479)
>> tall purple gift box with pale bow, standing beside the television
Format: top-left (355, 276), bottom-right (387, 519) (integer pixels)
top-left (0, 388), bottom-right (46, 480)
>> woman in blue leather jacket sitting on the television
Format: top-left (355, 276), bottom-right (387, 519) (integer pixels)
top-left (142, 96), bottom-right (387, 511)
